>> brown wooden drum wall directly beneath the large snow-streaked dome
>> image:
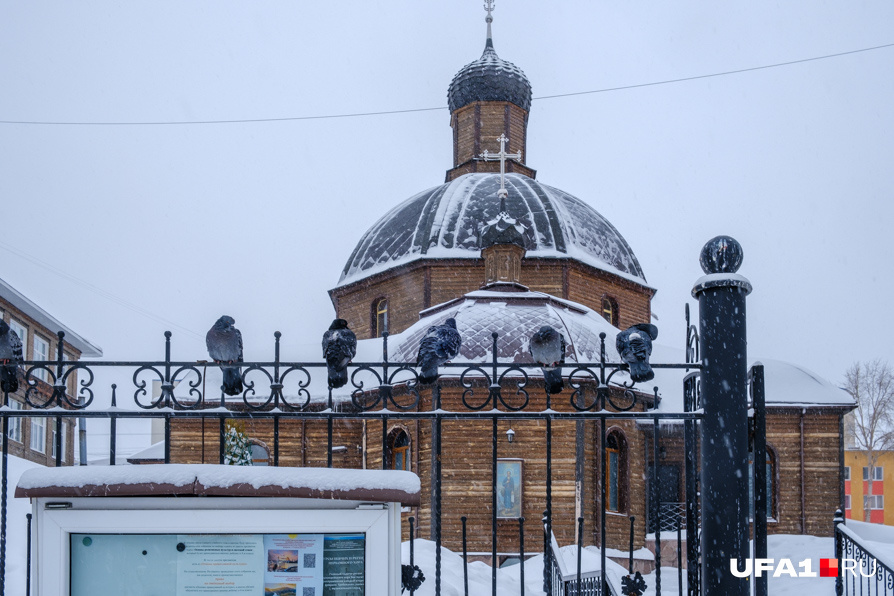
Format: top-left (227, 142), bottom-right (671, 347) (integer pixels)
top-left (329, 258), bottom-right (655, 339)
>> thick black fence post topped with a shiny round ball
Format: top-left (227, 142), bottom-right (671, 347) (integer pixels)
top-left (692, 236), bottom-right (751, 596)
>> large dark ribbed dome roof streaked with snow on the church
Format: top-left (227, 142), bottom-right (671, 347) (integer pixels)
top-left (338, 173), bottom-right (646, 287)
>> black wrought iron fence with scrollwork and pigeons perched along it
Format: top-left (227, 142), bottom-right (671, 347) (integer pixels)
top-left (0, 332), bottom-right (720, 594)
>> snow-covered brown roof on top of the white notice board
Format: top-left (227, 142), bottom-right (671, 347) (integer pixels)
top-left (16, 464), bottom-right (420, 506)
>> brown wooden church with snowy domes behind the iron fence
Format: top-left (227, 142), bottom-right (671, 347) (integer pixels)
top-left (171, 3), bottom-right (853, 559)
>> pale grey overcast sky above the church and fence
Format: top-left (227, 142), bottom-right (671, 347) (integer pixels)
top-left (0, 0), bottom-right (894, 452)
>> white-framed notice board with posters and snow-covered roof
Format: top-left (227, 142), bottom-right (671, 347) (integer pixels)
top-left (16, 465), bottom-right (420, 596)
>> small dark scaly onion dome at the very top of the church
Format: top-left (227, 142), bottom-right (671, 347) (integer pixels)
top-left (447, 37), bottom-right (531, 112)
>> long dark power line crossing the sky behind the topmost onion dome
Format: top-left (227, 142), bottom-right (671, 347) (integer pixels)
top-left (0, 43), bottom-right (894, 126)
